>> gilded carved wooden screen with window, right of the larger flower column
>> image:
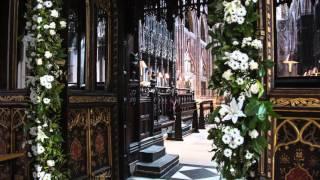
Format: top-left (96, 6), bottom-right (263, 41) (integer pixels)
top-left (260, 0), bottom-right (320, 180)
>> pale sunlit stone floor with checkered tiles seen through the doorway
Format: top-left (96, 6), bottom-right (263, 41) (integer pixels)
top-left (129, 127), bottom-right (220, 180)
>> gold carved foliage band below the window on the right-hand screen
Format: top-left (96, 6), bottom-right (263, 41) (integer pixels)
top-left (270, 98), bottom-right (320, 107)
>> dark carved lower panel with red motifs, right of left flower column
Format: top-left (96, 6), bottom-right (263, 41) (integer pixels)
top-left (67, 107), bottom-right (112, 179)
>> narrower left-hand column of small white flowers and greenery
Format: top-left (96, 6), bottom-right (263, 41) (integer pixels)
top-left (25, 0), bottom-right (67, 180)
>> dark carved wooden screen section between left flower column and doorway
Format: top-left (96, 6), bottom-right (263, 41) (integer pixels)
top-left (66, 0), bottom-right (117, 179)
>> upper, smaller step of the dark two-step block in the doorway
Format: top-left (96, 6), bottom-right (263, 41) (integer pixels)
top-left (140, 145), bottom-right (166, 162)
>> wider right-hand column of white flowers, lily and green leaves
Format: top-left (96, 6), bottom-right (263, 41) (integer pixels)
top-left (208, 0), bottom-right (276, 180)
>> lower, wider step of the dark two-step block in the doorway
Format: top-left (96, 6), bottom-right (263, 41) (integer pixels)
top-left (135, 154), bottom-right (179, 178)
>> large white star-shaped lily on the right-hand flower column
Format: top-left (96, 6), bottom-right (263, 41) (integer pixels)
top-left (221, 98), bottom-right (246, 124)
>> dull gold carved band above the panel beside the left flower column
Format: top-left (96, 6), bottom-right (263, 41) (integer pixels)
top-left (69, 96), bottom-right (117, 103)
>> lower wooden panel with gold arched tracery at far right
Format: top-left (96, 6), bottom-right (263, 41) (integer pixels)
top-left (273, 117), bottom-right (320, 180)
